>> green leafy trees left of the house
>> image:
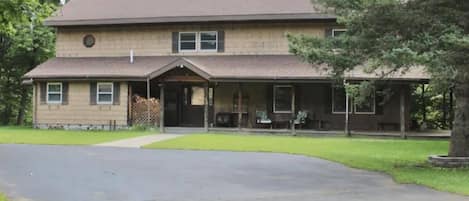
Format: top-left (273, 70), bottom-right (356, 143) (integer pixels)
top-left (0, 0), bottom-right (55, 125)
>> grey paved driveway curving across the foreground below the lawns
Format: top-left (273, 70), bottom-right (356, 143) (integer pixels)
top-left (0, 145), bottom-right (469, 201)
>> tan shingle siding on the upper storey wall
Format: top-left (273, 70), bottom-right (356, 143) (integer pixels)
top-left (57, 23), bottom-right (327, 57)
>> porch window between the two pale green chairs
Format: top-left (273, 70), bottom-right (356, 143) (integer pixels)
top-left (273, 86), bottom-right (293, 113)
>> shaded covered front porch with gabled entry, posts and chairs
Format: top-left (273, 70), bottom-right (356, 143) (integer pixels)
top-left (125, 56), bottom-right (426, 137)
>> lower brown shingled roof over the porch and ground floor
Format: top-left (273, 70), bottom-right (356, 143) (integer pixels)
top-left (24, 55), bottom-right (429, 81)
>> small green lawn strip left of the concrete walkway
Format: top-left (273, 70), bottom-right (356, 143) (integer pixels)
top-left (0, 127), bottom-right (155, 145)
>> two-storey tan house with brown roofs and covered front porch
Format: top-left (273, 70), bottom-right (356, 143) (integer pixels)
top-left (24, 0), bottom-right (428, 131)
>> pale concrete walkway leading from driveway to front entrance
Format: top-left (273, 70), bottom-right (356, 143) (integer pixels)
top-left (95, 134), bottom-right (184, 148)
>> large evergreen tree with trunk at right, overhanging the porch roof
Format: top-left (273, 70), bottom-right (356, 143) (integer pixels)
top-left (289, 0), bottom-right (469, 157)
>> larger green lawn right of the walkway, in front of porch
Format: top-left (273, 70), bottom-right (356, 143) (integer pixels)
top-left (146, 134), bottom-right (469, 195)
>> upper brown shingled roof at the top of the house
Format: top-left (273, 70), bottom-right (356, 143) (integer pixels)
top-left (46, 0), bottom-right (335, 26)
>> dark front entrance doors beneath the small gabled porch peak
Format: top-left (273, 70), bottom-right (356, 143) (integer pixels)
top-left (165, 85), bottom-right (205, 127)
